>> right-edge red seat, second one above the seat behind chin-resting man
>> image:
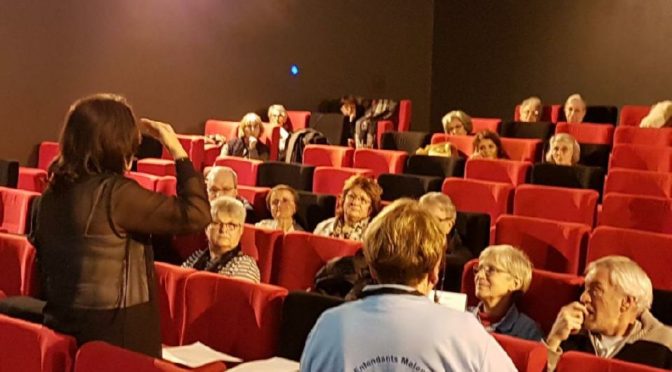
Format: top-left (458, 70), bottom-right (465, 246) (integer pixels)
top-left (604, 168), bottom-right (672, 198)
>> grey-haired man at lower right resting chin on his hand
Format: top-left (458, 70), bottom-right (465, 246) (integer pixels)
top-left (546, 256), bottom-right (672, 371)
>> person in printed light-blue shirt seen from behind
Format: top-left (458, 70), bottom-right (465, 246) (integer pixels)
top-left (301, 199), bottom-right (516, 372)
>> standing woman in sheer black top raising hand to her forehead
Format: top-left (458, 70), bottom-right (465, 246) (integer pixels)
top-left (32, 94), bottom-right (210, 357)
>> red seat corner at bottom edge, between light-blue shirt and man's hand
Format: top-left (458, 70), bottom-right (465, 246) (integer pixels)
top-left (492, 333), bottom-right (546, 372)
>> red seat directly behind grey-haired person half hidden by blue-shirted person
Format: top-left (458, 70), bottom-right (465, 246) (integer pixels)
top-left (441, 177), bottom-right (513, 226)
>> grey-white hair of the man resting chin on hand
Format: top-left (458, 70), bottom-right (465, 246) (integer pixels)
top-left (586, 256), bottom-right (653, 313)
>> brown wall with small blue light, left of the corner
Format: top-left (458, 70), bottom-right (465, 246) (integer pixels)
top-left (0, 0), bottom-right (433, 164)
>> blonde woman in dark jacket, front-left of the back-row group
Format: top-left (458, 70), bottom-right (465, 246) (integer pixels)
top-left (221, 112), bottom-right (270, 160)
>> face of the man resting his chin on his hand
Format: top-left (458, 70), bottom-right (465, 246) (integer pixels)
top-left (579, 267), bottom-right (626, 333)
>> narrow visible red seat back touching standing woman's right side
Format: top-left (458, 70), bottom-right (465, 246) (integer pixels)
top-left (154, 262), bottom-right (196, 346)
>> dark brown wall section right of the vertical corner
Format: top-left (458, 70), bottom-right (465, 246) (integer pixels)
top-left (432, 0), bottom-right (672, 130)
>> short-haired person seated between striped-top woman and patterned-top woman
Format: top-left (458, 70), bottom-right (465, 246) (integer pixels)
top-left (256, 185), bottom-right (303, 232)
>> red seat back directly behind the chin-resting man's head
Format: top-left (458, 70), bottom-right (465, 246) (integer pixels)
top-left (586, 226), bottom-right (672, 291)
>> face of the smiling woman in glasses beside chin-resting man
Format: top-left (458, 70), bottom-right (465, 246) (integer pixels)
top-left (474, 259), bottom-right (520, 302)
